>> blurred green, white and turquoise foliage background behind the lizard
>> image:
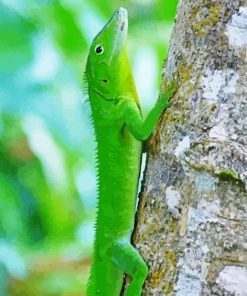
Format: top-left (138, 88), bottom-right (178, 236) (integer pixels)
top-left (0, 0), bottom-right (177, 296)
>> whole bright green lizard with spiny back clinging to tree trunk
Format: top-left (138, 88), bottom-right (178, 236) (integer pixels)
top-left (85, 8), bottom-right (174, 296)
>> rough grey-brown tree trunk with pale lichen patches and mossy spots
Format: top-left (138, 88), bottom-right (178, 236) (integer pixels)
top-left (133, 0), bottom-right (247, 296)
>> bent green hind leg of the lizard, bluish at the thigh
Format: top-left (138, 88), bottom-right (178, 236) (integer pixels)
top-left (111, 239), bottom-right (148, 296)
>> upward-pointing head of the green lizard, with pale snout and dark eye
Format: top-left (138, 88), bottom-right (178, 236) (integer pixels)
top-left (86, 8), bottom-right (128, 100)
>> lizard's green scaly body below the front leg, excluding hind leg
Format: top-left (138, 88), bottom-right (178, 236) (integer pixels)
top-left (88, 121), bottom-right (142, 296)
